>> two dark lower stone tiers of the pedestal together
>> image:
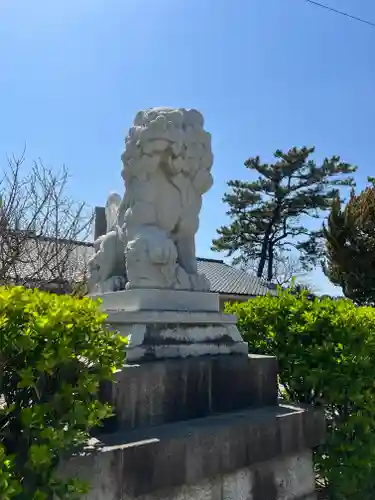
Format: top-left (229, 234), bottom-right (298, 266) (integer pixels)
top-left (61, 355), bottom-right (325, 500)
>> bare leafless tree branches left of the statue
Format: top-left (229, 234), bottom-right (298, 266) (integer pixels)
top-left (0, 152), bottom-right (92, 288)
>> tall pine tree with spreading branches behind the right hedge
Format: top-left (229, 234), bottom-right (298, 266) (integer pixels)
top-left (212, 147), bottom-right (356, 281)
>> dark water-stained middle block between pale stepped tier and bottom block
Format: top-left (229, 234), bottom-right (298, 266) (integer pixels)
top-left (101, 355), bottom-right (277, 432)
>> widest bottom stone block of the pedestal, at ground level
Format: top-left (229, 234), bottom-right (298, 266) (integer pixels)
top-left (61, 405), bottom-right (325, 500)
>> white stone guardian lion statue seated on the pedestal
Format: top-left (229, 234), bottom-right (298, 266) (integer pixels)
top-left (89, 108), bottom-right (213, 293)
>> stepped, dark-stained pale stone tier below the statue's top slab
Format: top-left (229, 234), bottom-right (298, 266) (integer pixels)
top-left (108, 311), bottom-right (248, 362)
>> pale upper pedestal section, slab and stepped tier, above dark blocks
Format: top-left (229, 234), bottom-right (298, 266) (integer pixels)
top-left (93, 289), bottom-right (248, 362)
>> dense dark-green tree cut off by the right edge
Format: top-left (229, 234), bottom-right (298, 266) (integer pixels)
top-left (324, 178), bottom-right (375, 305)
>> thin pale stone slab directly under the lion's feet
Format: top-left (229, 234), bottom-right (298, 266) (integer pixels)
top-left (90, 288), bottom-right (219, 312)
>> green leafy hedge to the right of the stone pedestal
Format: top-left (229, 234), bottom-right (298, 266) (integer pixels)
top-left (226, 291), bottom-right (375, 499)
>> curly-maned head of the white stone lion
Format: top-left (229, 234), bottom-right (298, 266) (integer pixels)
top-left (122, 108), bottom-right (213, 189)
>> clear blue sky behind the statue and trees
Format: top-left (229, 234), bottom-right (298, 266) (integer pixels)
top-left (0, 0), bottom-right (375, 292)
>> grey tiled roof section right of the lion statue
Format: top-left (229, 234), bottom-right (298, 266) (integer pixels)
top-left (197, 258), bottom-right (276, 296)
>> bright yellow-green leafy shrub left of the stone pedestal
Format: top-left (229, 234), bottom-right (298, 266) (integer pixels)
top-left (0, 287), bottom-right (125, 500)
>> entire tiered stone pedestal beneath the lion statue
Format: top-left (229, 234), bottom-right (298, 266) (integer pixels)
top-left (68, 290), bottom-right (325, 500)
